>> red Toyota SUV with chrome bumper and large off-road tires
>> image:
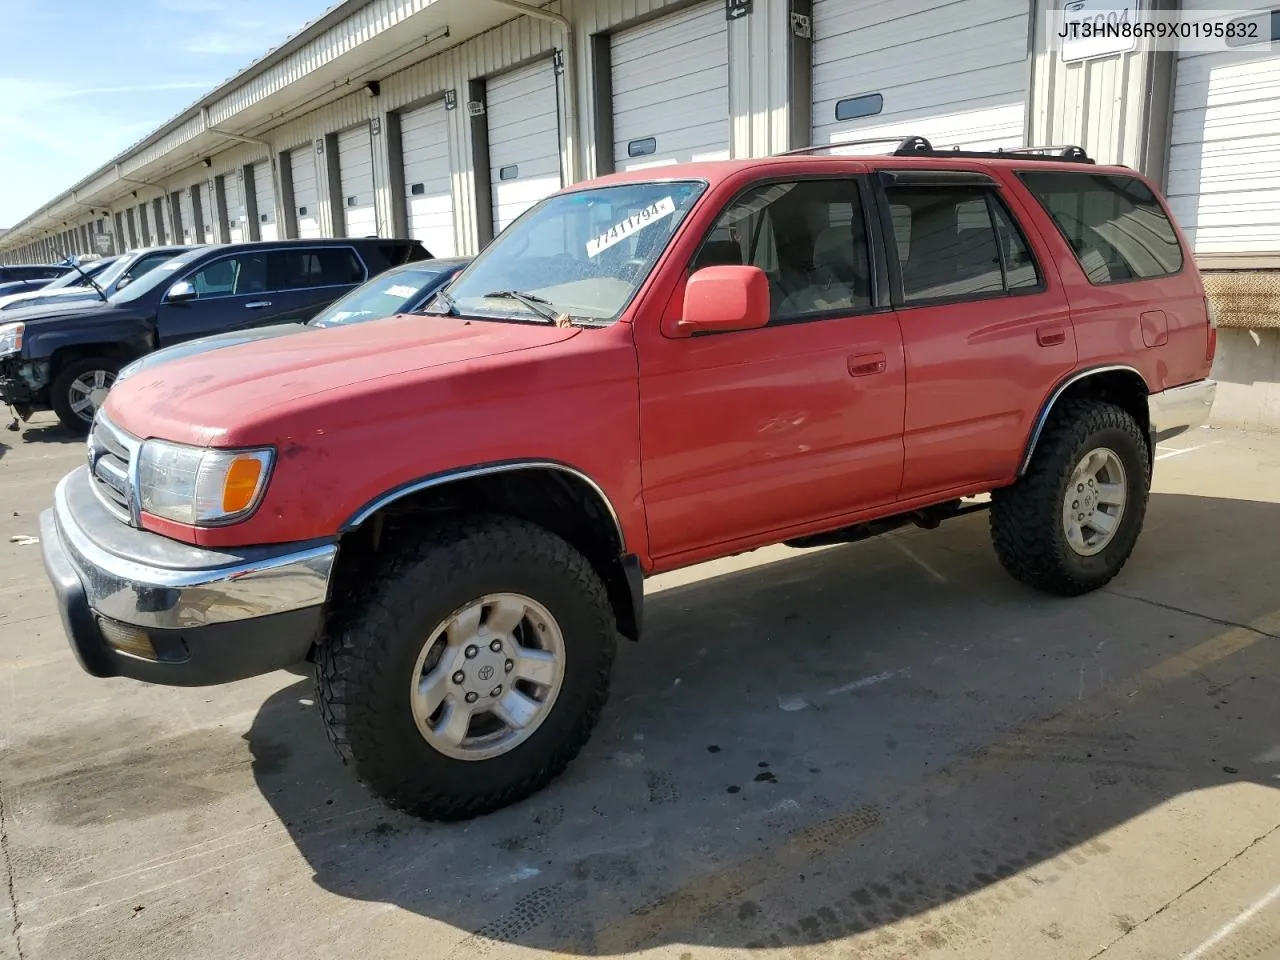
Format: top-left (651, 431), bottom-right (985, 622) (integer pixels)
top-left (41, 138), bottom-right (1216, 818)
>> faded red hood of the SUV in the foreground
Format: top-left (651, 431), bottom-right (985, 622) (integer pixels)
top-left (105, 316), bottom-right (580, 445)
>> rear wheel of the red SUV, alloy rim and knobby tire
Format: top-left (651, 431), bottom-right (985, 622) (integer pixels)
top-left (991, 401), bottom-right (1151, 596)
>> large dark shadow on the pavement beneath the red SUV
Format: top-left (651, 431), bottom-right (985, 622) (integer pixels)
top-left (247, 495), bottom-right (1280, 957)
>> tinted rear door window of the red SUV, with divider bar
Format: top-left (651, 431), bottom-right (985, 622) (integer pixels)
top-left (887, 187), bottom-right (1039, 303)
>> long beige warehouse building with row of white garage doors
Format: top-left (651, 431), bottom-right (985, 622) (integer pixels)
top-left (0, 0), bottom-right (1280, 426)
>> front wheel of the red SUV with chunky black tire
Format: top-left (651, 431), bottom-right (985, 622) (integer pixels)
top-left (316, 517), bottom-right (616, 819)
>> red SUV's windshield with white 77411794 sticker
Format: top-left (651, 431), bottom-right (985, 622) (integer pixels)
top-left (431, 180), bottom-right (707, 323)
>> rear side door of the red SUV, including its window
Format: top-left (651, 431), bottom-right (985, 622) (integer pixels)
top-left (879, 169), bottom-right (1076, 499)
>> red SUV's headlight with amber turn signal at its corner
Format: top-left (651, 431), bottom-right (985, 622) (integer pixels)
top-left (138, 440), bottom-right (275, 526)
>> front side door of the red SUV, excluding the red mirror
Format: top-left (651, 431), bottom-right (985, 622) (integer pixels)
top-left (636, 175), bottom-right (906, 568)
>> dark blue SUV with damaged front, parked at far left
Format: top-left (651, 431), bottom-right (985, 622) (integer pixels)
top-left (0, 238), bottom-right (430, 433)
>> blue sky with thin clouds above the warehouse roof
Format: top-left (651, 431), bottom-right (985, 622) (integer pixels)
top-left (0, 0), bottom-right (333, 227)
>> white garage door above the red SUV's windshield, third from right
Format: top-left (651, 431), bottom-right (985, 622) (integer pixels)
top-left (609, 4), bottom-right (730, 170)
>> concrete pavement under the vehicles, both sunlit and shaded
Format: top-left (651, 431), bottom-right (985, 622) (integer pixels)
top-left (0, 421), bottom-right (1280, 960)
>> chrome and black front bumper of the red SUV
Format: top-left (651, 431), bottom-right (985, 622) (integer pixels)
top-left (40, 467), bottom-right (338, 686)
